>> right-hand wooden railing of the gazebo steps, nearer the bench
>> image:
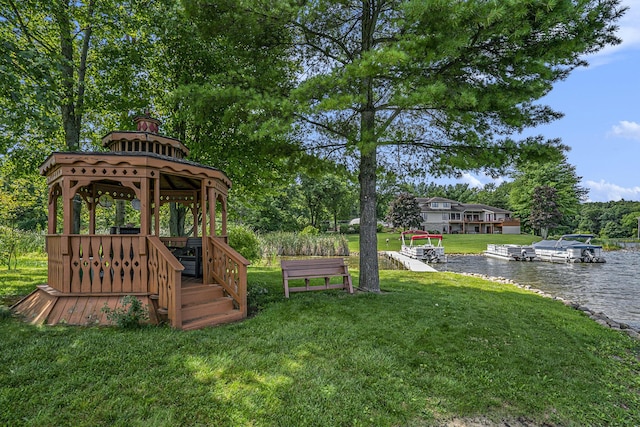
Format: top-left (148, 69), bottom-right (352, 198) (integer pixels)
top-left (210, 237), bottom-right (249, 316)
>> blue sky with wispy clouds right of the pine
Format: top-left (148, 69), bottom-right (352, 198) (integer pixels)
top-left (438, 0), bottom-right (640, 202)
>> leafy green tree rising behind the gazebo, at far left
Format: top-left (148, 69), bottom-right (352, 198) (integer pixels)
top-left (0, 0), bottom-right (170, 232)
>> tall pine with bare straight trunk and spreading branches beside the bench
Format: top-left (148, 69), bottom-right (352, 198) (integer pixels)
top-left (185, 0), bottom-right (623, 292)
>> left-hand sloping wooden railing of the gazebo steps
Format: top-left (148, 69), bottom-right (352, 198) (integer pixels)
top-left (147, 236), bottom-right (184, 328)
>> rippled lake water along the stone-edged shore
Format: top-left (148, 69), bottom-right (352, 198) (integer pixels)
top-left (433, 250), bottom-right (640, 329)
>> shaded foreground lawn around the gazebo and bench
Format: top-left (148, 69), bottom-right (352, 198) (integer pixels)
top-left (0, 260), bottom-right (640, 426)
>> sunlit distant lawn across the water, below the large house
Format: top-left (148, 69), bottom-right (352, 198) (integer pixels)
top-left (347, 233), bottom-right (540, 254)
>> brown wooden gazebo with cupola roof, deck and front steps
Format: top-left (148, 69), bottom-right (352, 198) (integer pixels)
top-left (14, 116), bottom-right (249, 329)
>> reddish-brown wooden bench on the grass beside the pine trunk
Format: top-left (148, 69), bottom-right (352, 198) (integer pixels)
top-left (280, 258), bottom-right (353, 298)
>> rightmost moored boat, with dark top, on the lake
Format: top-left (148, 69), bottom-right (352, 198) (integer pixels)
top-left (532, 234), bottom-right (605, 263)
